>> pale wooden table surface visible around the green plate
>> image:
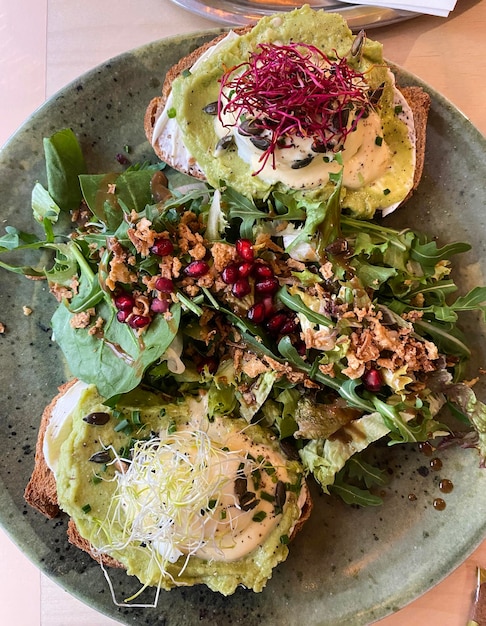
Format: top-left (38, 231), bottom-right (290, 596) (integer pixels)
top-left (0, 0), bottom-right (486, 626)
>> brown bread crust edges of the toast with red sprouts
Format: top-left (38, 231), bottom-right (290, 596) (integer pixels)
top-left (144, 31), bottom-right (430, 204)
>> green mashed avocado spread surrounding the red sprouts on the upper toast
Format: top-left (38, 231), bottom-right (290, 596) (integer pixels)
top-left (171, 6), bottom-right (415, 217)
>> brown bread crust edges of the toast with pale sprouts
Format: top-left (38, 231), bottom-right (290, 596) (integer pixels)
top-left (24, 379), bottom-right (312, 569)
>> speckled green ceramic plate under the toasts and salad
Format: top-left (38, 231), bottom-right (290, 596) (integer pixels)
top-left (0, 31), bottom-right (486, 626)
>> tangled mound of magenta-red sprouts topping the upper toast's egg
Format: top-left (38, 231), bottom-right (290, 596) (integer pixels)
top-left (218, 43), bottom-right (370, 173)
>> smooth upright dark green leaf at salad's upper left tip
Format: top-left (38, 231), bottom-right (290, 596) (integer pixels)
top-left (44, 128), bottom-right (86, 211)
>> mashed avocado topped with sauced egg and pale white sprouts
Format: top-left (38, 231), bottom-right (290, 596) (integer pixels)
top-left (56, 386), bottom-right (302, 595)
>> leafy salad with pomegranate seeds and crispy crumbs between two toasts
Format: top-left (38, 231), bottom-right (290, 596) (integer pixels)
top-left (0, 130), bottom-right (486, 505)
